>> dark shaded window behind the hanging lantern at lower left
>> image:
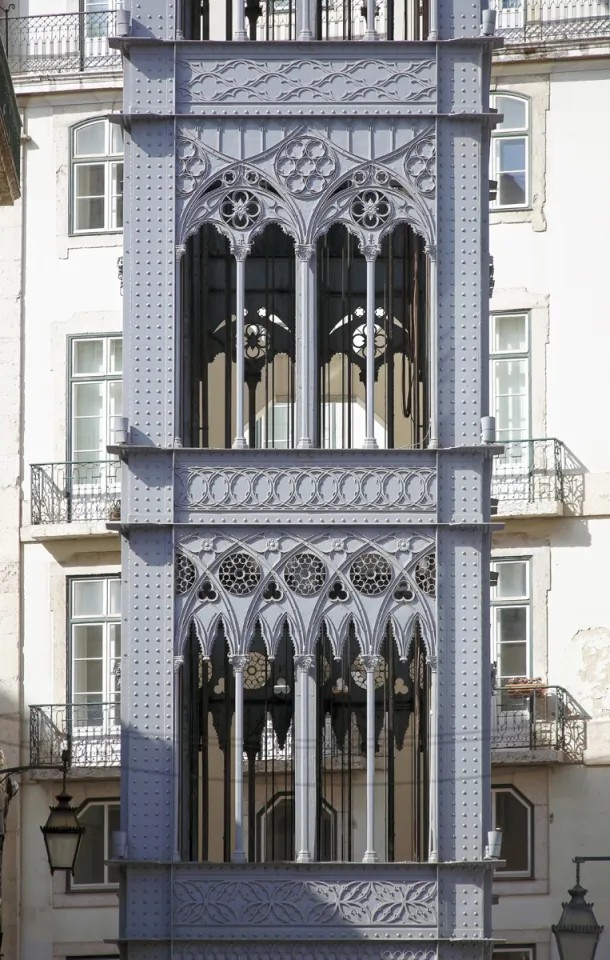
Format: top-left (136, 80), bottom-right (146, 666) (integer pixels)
top-left (70, 799), bottom-right (120, 889)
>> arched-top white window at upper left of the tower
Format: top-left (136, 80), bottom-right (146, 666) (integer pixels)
top-left (72, 119), bottom-right (123, 233)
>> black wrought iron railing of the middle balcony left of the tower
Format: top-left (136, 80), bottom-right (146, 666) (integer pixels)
top-left (31, 460), bottom-right (121, 524)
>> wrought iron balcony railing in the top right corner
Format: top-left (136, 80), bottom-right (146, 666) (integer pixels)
top-left (491, 0), bottom-right (610, 44)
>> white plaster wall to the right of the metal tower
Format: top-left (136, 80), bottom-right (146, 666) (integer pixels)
top-left (491, 58), bottom-right (610, 960)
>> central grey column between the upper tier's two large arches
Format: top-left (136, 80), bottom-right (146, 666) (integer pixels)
top-left (295, 243), bottom-right (317, 450)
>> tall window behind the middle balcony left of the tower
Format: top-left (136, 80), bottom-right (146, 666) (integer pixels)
top-left (70, 336), bottom-right (123, 463)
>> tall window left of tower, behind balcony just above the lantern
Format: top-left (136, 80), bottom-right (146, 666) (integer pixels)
top-left (70, 577), bottom-right (121, 735)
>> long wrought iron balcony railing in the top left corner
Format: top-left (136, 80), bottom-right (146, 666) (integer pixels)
top-left (2, 10), bottom-right (121, 75)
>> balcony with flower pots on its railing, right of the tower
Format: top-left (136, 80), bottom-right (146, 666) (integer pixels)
top-left (491, 683), bottom-right (589, 764)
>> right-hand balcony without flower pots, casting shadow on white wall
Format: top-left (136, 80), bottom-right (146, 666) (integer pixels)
top-left (491, 438), bottom-right (584, 517)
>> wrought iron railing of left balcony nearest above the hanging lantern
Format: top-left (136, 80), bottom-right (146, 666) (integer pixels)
top-left (30, 698), bottom-right (121, 769)
